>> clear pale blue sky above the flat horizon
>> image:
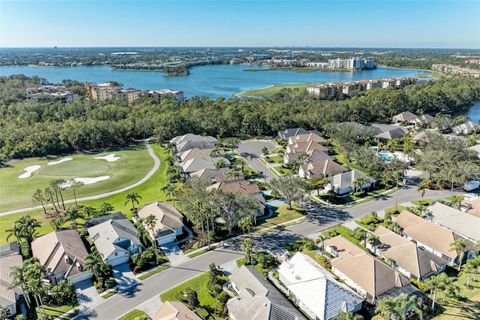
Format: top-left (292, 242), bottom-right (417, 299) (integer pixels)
top-left (0, 0), bottom-right (480, 48)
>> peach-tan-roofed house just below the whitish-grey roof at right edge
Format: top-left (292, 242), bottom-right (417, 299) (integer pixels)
top-left (395, 211), bottom-right (475, 266)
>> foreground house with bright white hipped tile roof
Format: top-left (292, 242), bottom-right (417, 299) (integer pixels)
top-left (278, 252), bottom-right (363, 320)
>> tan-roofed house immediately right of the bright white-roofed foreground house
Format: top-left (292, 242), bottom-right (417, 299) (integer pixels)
top-left (325, 236), bottom-right (418, 304)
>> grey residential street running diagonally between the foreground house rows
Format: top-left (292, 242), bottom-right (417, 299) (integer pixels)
top-left (76, 187), bottom-right (462, 319)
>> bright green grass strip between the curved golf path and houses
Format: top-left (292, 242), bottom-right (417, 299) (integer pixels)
top-left (0, 144), bottom-right (169, 245)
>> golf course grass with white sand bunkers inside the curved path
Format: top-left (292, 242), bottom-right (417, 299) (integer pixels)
top-left (0, 144), bottom-right (153, 212)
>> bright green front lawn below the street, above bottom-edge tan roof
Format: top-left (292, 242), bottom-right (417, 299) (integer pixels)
top-left (160, 272), bottom-right (222, 308)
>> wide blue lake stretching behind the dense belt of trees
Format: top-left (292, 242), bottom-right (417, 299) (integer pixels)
top-left (0, 65), bottom-right (425, 98)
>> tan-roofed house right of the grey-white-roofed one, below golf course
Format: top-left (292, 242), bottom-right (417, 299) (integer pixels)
top-left (138, 201), bottom-right (186, 245)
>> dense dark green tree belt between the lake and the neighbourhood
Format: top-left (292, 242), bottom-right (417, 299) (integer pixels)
top-left (0, 77), bottom-right (480, 159)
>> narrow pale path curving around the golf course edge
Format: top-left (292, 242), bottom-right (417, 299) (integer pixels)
top-left (0, 141), bottom-right (160, 217)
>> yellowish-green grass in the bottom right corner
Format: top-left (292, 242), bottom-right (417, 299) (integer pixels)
top-left (433, 274), bottom-right (480, 320)
